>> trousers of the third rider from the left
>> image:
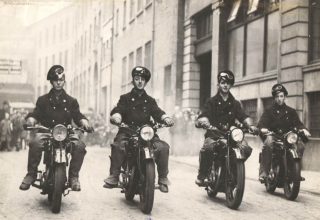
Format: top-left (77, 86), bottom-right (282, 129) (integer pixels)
top-left (198, 137), bottom-right (252, 179)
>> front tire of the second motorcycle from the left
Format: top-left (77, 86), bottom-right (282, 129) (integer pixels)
top-left (140, 160), bottom-right (155, 214)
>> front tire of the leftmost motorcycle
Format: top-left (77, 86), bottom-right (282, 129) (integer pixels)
top-left (51, 163), bottom-right (66, 213)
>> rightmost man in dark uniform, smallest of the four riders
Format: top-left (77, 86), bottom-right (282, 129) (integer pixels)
top-left (258, 84), bottom-right (311, 182)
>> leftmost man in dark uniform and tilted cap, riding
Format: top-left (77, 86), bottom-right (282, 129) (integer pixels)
top-left (20, 65), bottom-right (92, 191)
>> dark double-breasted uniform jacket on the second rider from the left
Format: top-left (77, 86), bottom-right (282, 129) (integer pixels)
top-left (110, 89), bottom-right (165, 126)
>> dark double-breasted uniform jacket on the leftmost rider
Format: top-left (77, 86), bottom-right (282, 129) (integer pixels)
top-left (26, 89), bottom-right (86, 128)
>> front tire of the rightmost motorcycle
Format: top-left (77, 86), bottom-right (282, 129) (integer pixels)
top-left (283, 160), bottom-right (301, 201)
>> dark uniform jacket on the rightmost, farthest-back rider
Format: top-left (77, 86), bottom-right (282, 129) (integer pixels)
top-left (258, 103), bottom-right (305, 133)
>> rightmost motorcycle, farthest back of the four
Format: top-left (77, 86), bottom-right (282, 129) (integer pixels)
top-left (259, 128), bottom-right (308, 200)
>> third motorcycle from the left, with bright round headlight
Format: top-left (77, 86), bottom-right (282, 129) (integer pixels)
top-left (203, 125), bottom-right (253, 209)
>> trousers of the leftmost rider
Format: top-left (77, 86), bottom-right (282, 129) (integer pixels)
top-left (28, 133), bottom-right (87, 178)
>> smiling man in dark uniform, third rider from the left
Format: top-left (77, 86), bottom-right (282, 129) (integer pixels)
top-left (192, 70), bottom-right (257, 186)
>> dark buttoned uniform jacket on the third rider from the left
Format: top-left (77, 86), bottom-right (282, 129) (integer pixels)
top-left (198, 92), bottom-right (249, 137)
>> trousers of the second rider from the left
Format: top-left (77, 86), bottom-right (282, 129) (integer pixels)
top-left (110, 132), bottom-right (169, 184)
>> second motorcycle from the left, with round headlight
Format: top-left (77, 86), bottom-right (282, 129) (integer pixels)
top-left (114, 123), bottom-right (167, 214)
